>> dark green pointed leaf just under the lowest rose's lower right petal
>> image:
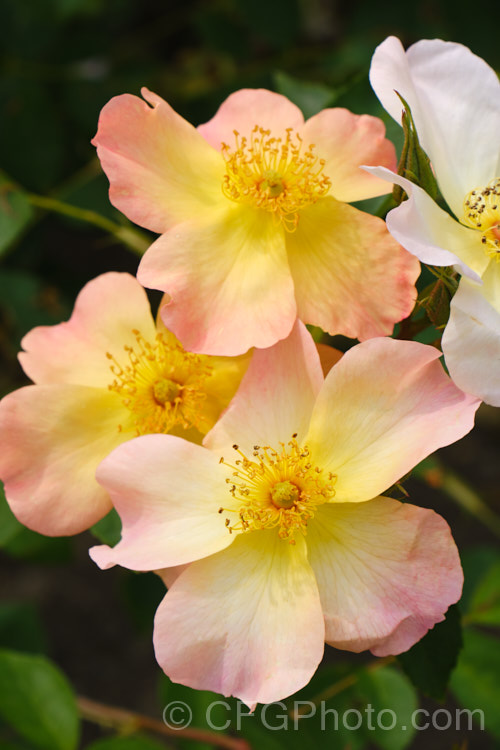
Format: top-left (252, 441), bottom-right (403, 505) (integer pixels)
top-left (398, 604), bottom-right (462, 700)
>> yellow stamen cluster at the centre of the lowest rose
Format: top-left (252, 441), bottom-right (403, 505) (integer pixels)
top-left (219, 434), bottom-right (337, 544)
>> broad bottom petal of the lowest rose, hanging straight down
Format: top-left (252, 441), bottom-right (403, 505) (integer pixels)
top-left (154, 531), bottom-right (324, 708)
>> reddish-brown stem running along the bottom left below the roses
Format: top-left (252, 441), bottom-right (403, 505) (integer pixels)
top-left (77, 696), bottom-right (251, 750)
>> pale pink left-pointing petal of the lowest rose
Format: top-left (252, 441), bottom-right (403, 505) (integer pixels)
top-left (90, 435), bottom-right (234, 570)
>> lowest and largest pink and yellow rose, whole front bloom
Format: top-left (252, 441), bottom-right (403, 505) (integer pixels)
top-left (91, 323), bottom-right (478, 706)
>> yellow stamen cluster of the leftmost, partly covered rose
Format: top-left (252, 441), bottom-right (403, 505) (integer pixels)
top-left (106, 330), bottom-right (212, 435)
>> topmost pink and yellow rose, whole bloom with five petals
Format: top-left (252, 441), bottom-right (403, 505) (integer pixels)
top-left (93, 89), bottom-right (419, 355)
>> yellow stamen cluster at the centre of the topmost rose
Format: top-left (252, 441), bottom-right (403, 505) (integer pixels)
top-left (222, 125), bottom-right (332, 232)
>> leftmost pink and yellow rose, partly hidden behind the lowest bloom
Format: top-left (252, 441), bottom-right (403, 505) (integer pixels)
top-left (0, 273), bottom-right (248, 536)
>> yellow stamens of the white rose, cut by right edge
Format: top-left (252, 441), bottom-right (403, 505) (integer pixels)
top-left (462, 177), bottom-right (500, 261)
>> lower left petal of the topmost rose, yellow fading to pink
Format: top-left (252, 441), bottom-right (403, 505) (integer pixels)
top-left (138, 203), bottom-right (296, 355)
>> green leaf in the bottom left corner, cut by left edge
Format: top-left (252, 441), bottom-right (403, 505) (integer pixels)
top-left (0, 649), bottom-right (79, 750)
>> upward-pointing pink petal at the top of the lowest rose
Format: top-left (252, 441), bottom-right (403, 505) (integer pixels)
top-left (204, 321), bottom-right (323, 458)
